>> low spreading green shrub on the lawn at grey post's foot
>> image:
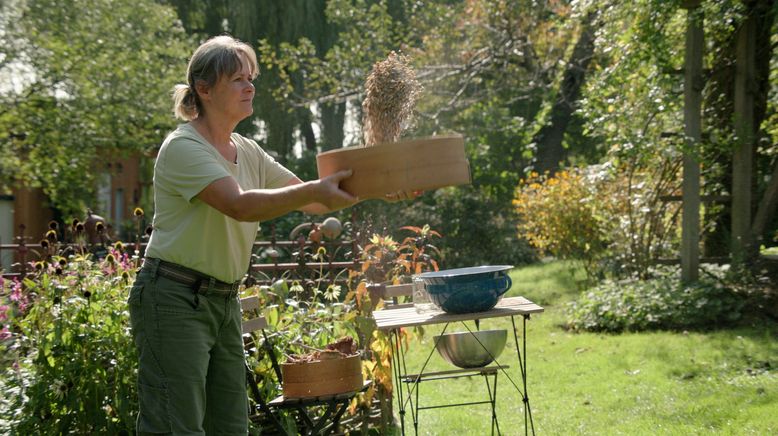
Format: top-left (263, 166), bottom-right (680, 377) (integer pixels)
top-left (568, 269), bottom-right (746, 332)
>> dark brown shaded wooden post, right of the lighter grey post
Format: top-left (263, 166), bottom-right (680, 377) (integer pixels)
top-left (731, 8), bottom-right (756, 265)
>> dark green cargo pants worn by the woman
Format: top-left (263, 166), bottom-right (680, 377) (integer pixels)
top-left (128, 262), bottom-right (248, 435)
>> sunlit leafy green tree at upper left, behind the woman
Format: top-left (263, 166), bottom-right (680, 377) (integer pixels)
top-left (0, 0), bottom-right (188, 215)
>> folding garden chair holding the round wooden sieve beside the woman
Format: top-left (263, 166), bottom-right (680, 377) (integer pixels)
top-left (241, 297), bottom-right (370, 435)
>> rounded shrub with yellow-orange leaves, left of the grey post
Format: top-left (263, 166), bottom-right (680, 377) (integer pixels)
top-left (513, 159), bottom-right (679, 281)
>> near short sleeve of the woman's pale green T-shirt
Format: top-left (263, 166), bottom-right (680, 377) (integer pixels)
top-left (154, 137), bottom-right (232, 201)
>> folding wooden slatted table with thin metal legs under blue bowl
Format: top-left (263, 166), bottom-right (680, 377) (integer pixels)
top-left (373, 297), bottom-right (543, 435)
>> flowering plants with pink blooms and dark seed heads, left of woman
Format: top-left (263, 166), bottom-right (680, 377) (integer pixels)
top-left (0, 249), bottom-right (137, 434)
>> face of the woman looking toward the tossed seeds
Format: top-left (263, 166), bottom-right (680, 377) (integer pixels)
top-left (210, 56), bottom-right (254, 121)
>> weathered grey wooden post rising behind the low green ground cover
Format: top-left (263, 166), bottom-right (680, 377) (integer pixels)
top-left (681, 2), bottom-right (704, 283)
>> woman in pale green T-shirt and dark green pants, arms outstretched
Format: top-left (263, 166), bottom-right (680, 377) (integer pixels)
top-left (128, 36), bottom-right (357, 435)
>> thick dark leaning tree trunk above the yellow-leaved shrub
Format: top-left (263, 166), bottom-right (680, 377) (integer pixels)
top-left (533, 11), bottom-right (597, 173)
